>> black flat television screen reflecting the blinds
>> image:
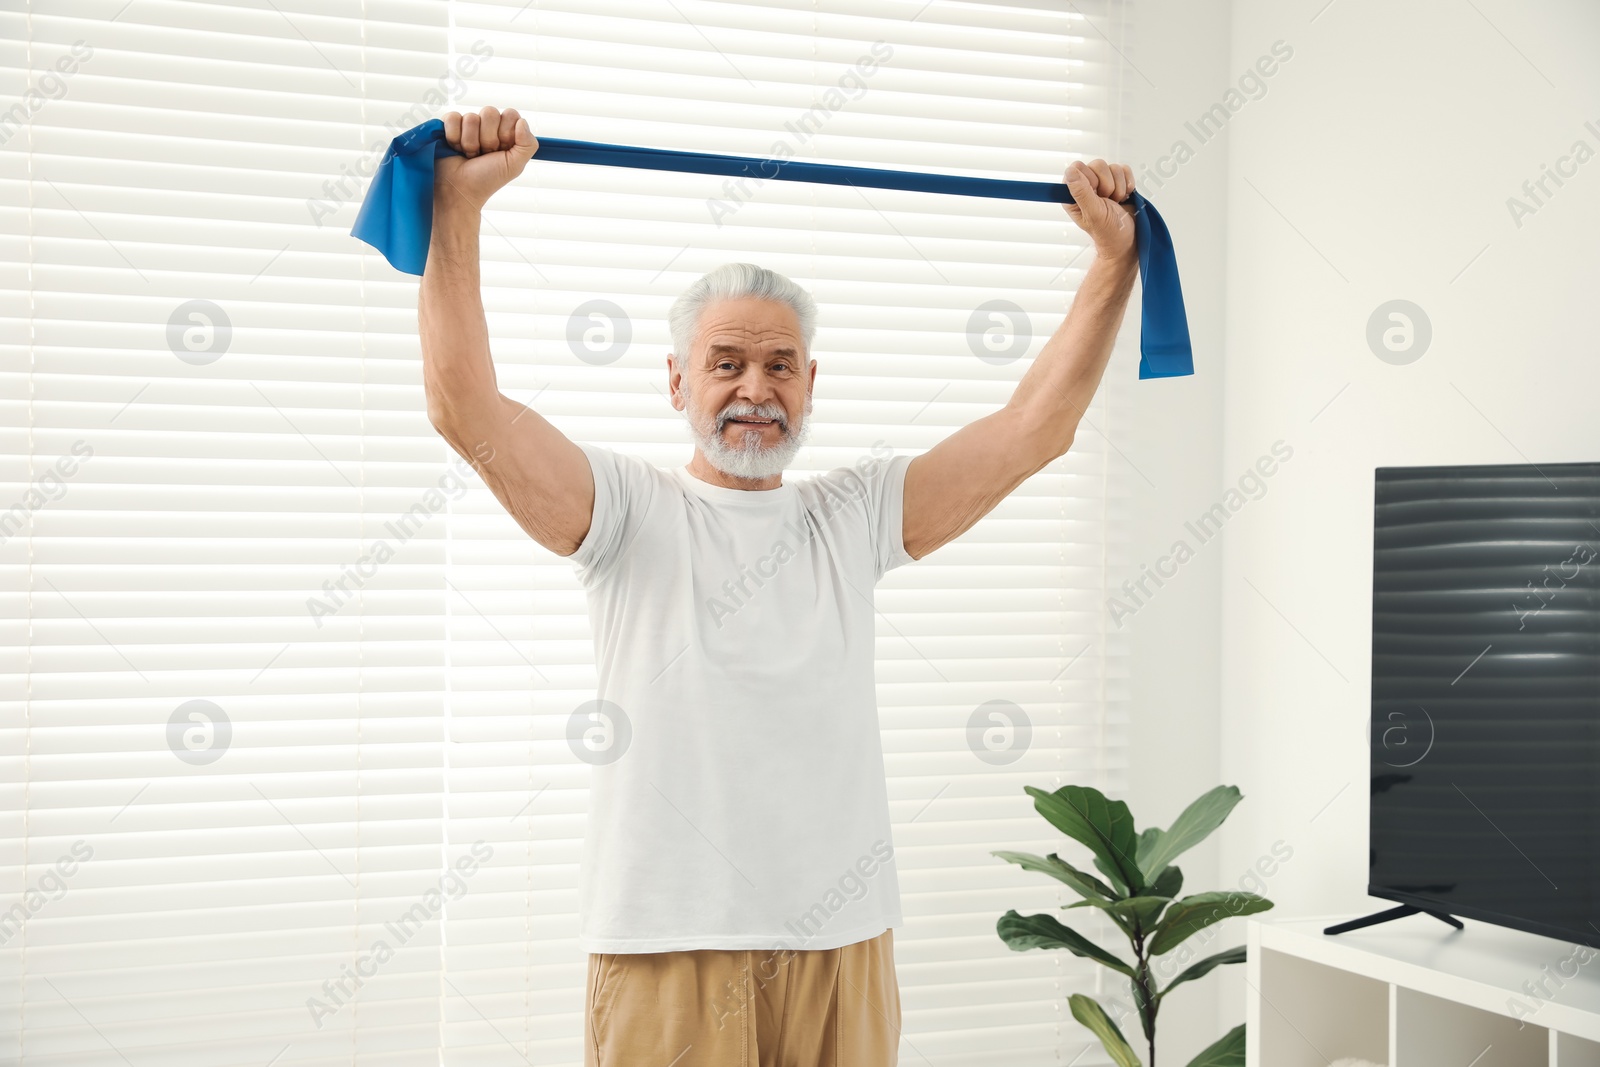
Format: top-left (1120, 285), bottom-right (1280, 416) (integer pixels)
top-left (1368, 462), bottom-right (1600, 947)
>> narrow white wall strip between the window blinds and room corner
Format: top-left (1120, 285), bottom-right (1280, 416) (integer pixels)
top-left (1120, 0), bottom-right (1228, 1064)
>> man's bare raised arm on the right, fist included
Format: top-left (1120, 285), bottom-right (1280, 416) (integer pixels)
top-left (901, 160), bottom-right (1139, 560)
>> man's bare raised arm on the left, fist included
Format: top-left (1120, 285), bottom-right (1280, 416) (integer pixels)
top-left (416, 107), bottom-right (595, 555)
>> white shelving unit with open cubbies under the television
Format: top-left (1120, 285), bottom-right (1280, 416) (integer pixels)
top-left (1245, 904), bottom-right (1600, 1067)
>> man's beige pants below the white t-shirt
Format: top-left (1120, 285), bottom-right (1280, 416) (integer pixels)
top-left (584, 929), bottom-right (901, 1067)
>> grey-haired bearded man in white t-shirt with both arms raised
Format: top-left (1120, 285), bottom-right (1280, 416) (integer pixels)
top-left (418, 107), bottom-right (1138, 1067)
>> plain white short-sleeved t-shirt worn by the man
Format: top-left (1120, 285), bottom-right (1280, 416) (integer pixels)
top-left (568, 445), bottom-right (912, 952)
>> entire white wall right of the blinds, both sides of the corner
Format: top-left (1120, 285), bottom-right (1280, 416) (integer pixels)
top-left (1107, 0), bottom-right (1600, 1064)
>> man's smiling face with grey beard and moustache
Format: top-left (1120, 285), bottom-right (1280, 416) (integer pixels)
top-left (672, 298), bottom-right (816, 478)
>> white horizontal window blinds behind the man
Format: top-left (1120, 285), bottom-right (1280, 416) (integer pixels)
top-left (0, 0), bottom-right (1126, 1067)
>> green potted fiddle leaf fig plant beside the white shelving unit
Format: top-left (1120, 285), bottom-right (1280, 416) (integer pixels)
top-left (992, 785), bottom-right (1272, 1067)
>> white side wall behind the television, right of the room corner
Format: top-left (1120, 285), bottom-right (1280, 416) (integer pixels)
top-left (1209, 0), bottom-right (1600, 1043)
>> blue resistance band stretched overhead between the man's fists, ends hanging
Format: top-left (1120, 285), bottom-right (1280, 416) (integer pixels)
top-left (350, 118), bottom-right (1195, 378)
